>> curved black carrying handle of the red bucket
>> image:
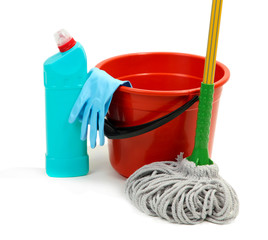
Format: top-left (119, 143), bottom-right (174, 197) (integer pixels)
top-left (104, 96), bottom-right (199, 139)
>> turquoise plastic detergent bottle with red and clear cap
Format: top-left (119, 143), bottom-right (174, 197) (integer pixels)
top-left (44, 30), bottom-right (89, 177)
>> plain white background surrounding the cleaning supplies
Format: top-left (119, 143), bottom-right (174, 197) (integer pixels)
top-left (0, 0), bottom-right (268, 240)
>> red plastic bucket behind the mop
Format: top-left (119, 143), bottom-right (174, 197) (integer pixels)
top-left (97, 53), bottom-right (230, 177)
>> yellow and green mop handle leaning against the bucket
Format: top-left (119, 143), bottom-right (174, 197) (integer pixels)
top-left (188, 0), bottom-right (223, 166)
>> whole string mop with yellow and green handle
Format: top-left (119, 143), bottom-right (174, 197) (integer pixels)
top-left (125, 0), bottom-right (239, 224)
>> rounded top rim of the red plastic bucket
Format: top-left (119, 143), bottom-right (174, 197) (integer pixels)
top-left (96, 52), bottom-right (230, 96)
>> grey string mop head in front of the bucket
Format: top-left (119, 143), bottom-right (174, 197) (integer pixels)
top-left (126, 155), bottom-right (239, 224)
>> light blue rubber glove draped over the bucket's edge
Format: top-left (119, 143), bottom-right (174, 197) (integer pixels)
top-left (69, 68), bottom-right (132, 148)
